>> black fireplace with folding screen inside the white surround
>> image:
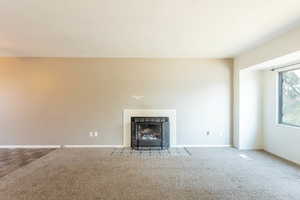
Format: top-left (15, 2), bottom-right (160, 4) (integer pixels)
top-left (131, 117), bottom-right (170, 150)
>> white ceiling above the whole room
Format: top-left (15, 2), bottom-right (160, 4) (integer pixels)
top-left (0, 0), bottom-right (300, 58)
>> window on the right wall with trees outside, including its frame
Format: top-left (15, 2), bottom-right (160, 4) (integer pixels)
top-left (279, 69), bottom-right (300, 127)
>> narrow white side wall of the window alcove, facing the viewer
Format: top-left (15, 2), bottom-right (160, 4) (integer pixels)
top-left (237, 69), bottom-right (263, 149)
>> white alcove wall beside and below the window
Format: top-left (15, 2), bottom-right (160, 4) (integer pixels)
top-left (264, 70), bottom-right (300, 164)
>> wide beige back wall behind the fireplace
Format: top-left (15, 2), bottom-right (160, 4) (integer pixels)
top-left (0, 58), bottom-right (232, 145)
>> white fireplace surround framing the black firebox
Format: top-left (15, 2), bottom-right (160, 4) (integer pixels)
top-left (123, 109), bottom-right (176, 147)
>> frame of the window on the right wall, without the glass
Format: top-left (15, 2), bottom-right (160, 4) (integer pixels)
top-left (277, 67), bottom-right (300, 128)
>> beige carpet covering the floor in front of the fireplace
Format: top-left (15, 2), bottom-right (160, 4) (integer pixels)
top-left (0, 148), bottom-right (300, 200)
